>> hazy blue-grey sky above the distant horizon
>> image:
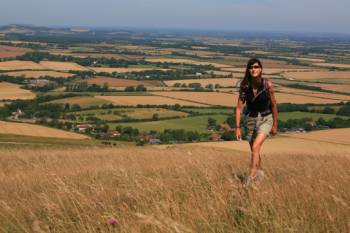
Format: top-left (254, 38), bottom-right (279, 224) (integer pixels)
top-left (0, 0), bottom-right (350, 33)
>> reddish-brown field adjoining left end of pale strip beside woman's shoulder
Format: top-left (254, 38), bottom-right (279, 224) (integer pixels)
top-left (87, 77), bottom-right (163, 87)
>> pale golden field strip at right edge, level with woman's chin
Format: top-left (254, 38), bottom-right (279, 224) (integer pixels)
top-left (283, 71), bottom-right (350, 81)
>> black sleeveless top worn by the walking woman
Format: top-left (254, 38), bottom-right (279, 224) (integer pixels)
top-left (240, 78), bottom-right (272, 117)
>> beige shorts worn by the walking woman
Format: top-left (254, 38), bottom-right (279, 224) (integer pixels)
top-left (245, 113), bottom-right (273, 142)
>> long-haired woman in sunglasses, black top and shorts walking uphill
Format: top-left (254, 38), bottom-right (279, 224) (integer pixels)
top-left (236, 58), bottom-right (277, 186)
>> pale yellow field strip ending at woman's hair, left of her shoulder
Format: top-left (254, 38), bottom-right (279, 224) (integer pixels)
top-left (164, 78), bottom-right (241, 87)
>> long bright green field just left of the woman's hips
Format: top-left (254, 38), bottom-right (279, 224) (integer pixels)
top-left (109, 115), bottom-right (227, 133)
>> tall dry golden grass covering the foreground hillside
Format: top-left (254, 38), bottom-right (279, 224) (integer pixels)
top-left (0, 147), bottom-right (350, 233)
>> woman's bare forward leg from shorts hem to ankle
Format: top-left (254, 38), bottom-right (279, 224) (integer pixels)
top-left (249, 133), bottom-right (267, 177)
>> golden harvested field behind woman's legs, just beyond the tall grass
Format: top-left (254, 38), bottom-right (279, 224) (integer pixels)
top-left (178, 136), bottom-right (350, 156)
